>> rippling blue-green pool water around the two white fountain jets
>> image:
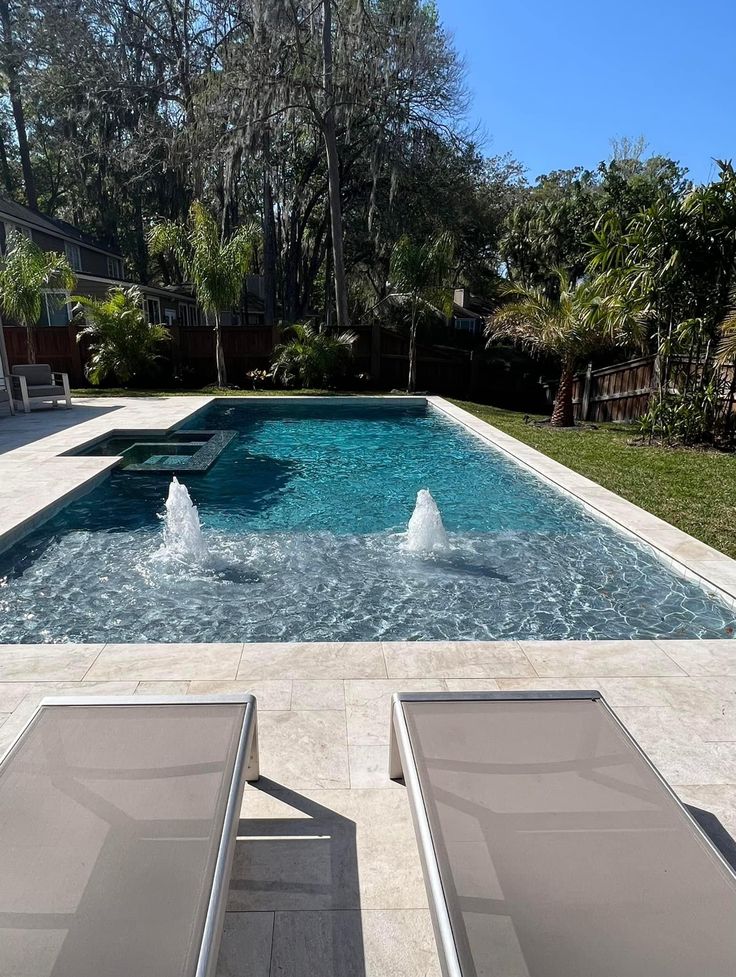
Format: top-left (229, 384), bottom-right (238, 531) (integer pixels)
top-left (0, 400), bottom-right (736, 642)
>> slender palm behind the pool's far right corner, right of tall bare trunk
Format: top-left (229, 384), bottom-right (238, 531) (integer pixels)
top-left (389, 233), bottom-right (454, 393)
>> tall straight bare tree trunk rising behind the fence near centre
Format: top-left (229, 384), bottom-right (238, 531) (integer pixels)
top-left (322, 0), bottom-right (350, 330)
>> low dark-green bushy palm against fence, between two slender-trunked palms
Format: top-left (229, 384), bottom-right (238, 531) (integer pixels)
top-left (271, 323), bottom-right (358, 388)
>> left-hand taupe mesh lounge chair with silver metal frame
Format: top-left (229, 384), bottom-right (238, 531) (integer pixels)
top-left (0, 695), bottom-right (258, 977)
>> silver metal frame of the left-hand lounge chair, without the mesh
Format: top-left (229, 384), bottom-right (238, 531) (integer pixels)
top-left (0, 692), bottom-right (260, 977)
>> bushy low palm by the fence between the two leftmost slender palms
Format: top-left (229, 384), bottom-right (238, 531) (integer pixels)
top-left (74, 285), bottom-right (171, 386)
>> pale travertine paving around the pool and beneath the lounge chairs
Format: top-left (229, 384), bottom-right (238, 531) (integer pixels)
top-left (0, 397), bottom-right (736, 977)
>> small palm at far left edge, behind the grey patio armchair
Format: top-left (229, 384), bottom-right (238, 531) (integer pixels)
top-left (0, 231), bottom-right (76, 363)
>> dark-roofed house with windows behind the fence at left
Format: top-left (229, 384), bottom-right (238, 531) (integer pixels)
top-left (0, 196), bottom-right (200, 326)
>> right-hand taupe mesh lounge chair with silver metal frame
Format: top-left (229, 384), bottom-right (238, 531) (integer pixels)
top-left (390, 692), bottom-right (736, 977)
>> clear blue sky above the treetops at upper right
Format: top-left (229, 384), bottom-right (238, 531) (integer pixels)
top-left (437, 0), bottom-right (736, 181)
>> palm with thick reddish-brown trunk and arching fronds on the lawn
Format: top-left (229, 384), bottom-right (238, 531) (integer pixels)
top-left (485, 271), bottom-right (637, 427)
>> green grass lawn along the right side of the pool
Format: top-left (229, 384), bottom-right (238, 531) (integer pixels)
top-left (453, 400), bottom-right (736, 558)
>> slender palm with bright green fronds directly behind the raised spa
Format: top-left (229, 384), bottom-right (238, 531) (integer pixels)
top-left (148, 200), bottom-right (257, 387)
